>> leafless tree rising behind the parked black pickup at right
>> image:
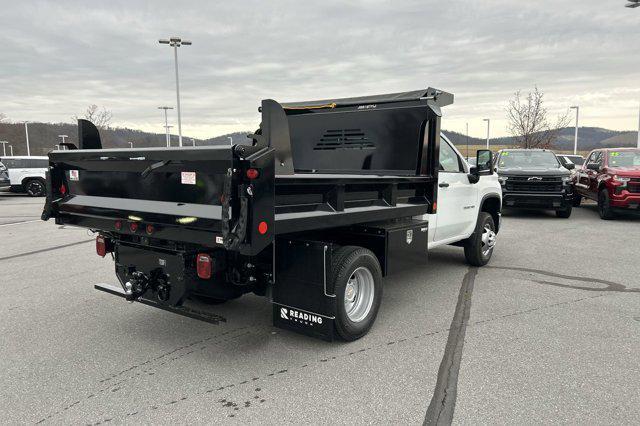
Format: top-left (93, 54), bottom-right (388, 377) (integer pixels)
top-left (506, 87), bottom-right (570, 148)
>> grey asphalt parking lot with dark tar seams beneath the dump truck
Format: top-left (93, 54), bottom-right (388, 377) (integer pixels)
top-left (0, 193), bottom-right (640, 424)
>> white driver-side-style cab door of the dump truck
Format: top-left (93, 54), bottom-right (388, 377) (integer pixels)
top-left (434, 138), bottom-right (478, 241)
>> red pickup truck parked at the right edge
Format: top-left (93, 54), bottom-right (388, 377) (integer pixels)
top-left (574, 148), bottom-right (640, 219)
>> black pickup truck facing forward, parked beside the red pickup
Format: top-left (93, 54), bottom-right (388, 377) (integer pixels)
top-left (496, 149), bottom-right (574, 218)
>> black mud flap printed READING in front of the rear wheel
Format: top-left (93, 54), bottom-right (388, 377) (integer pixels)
top-left (272, 238), bottom-right (336, 341)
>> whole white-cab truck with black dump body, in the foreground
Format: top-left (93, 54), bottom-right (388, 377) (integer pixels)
top-left (42, 89), bottom-right (501, 340)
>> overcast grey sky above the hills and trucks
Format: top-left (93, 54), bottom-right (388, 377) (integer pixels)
top-left (0, 0), bottom-right (640, 138)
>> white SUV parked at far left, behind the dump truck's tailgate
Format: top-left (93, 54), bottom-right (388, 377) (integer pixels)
top-left (0, 156), bottom-right (49, 197)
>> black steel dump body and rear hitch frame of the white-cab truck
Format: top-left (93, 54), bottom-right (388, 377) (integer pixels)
top-left (43, 89), bottom-right (453, 336)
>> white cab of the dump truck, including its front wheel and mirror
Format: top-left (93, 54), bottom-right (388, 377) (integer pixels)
top-left (424, 135), bottom-right (502, 266)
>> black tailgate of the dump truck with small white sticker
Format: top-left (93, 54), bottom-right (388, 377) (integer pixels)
top-left (45, 146), bottom-right (233, 236)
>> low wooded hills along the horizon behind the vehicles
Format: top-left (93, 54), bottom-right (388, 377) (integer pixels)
top-left (0, 123), bottom-right (638, 155)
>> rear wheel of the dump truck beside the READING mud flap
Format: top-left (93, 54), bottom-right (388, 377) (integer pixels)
top-left (331, 246), bottom-right (382, 341)
